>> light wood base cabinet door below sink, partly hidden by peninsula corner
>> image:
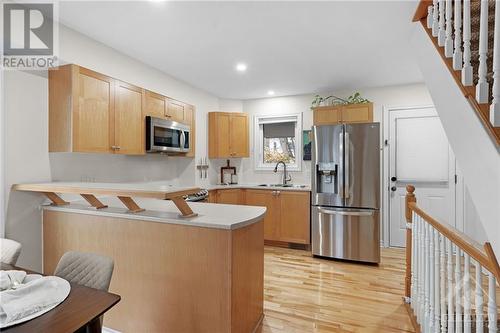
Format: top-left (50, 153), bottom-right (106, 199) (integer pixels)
top-left (245, 190), bottom-right (281, 241)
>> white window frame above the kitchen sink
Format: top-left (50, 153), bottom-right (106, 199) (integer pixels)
top-left (253, 112), bottom-right (302, 171)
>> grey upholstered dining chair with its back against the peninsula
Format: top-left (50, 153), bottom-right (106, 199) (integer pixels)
top-left (54, 251), bottom-right (114, 333)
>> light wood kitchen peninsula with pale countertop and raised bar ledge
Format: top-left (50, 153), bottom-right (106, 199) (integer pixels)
top-left (13, 183), bottom-right (266, 332)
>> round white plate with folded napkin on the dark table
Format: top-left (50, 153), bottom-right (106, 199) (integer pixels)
top-left (0, 275), bottom-right (71, 328)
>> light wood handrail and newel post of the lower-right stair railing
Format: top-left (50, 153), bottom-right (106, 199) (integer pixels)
top-left (405, 185), bottom-right (500, 281)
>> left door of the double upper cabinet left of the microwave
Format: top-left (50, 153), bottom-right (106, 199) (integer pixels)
top-left (73, 68), bottom-right (115, 153)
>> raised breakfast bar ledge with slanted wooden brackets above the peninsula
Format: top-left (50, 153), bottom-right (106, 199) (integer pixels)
top-left (12, 182), bottom-right (200, 217)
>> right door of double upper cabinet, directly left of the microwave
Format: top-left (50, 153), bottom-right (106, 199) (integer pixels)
top-left (113, 81), bottom-right (145, 155)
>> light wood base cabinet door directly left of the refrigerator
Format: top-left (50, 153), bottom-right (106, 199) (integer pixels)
top-left (279, 191), bottom-right (311, 244)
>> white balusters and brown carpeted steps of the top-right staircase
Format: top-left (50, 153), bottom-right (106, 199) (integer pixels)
top-left (413, 0), bottom-right (500, 141)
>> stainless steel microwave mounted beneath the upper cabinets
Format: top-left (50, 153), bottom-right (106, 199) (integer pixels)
top-left (146, 116), bottom-right (190, 153)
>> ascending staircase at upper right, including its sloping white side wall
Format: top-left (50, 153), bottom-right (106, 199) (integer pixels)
top-left (410, 0), bottom-right (500, 270)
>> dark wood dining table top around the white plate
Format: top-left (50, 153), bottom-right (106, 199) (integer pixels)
top-left (0, 263), bottom-right (120, 333)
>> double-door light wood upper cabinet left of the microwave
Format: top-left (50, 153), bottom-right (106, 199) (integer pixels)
top-left (49, 65), bottom-right (144, 155)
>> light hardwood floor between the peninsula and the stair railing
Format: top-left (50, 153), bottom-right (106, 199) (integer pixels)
top-left (257, 247), bottom-right (414, 333)
